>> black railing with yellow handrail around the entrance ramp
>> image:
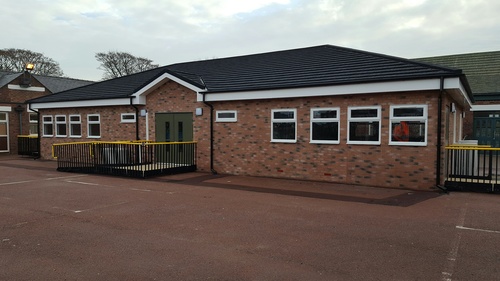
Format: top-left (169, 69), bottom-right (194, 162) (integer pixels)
top-left (52, 141), bottom-right (196, 178)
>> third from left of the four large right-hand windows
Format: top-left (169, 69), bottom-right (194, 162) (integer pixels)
top-left (347, 106), bottom-right (381, 144)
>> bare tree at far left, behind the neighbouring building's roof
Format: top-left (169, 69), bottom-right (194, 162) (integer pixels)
top-left (0, 48), bottom-right (64, 77)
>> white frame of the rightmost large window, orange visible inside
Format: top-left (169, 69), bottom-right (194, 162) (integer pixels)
top-left (389, 104), bottom-right (429, 146)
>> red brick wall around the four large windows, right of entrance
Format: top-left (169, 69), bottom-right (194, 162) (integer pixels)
top-left (209, 92), bottom-right (452, 189)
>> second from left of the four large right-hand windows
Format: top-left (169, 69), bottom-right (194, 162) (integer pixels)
top-left (311, 108), bottom-right (340, 144)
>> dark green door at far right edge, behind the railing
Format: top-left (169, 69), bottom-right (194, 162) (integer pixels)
top-left (474, 117), bottom-right (500, 147)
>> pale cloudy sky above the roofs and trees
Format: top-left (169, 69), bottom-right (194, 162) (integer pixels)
top-left (0, 0), bottom-right (500, 81)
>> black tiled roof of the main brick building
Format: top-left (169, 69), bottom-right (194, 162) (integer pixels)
top-left (29, 45), bottom-right (467, 103)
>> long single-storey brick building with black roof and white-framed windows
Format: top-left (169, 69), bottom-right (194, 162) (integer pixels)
top-left (29, 45), bottom-right (473, 189)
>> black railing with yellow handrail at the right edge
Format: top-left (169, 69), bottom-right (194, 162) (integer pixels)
top-left (445, 145), bottom-right (500, 192)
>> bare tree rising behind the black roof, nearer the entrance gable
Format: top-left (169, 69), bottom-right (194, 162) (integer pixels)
top-left (95, 51), bottom-right (159, 80)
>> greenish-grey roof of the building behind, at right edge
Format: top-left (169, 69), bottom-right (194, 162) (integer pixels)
top-left (415, 51), bottom-right (500, 96)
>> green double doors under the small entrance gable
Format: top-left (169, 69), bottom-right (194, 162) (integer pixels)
top-left (155, 113), bottom-right (194, 165)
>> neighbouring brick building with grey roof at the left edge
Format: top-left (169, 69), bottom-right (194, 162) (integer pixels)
top-left (0, 71), bottom-right (93, 154)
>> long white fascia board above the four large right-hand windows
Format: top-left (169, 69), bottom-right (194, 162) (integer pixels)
top-left (198, 79), bottom-right (446, 101)
